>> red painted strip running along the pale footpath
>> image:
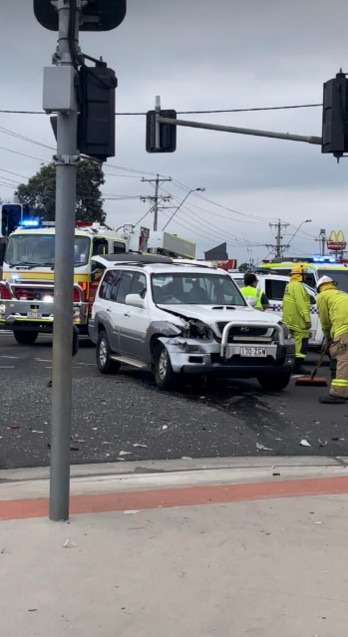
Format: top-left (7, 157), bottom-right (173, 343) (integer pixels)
top-left (0, 476), bottom-right (348, 520)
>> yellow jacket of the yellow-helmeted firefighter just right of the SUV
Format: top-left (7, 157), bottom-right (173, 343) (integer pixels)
top-left (283, 280), bottom-right (311, 332)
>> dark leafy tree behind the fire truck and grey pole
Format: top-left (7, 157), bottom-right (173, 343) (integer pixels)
top-left (15, 159), bottom-right (106, 223)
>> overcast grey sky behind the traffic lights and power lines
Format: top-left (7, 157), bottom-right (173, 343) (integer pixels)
top-left (0, 0), bottom-right (348, 262)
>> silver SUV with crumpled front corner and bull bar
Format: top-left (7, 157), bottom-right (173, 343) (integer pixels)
top-left (89, 254), bottom-right (295, 390)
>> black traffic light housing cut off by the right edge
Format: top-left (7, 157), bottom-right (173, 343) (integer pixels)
top-left (321, 72), bottom-right (348, 159)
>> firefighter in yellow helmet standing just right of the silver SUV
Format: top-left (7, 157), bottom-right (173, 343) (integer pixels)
top-left (283, 263), bottom-right (312, 374)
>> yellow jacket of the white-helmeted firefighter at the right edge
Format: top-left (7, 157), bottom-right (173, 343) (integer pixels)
top-left (317, 289), bottom-right (348, 339)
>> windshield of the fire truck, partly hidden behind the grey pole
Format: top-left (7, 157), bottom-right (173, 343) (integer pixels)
top-left (4, 233), bottom-right (91, 267)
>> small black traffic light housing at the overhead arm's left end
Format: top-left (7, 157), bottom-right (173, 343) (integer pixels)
top-left (146, 110), bottom-right (176, 153)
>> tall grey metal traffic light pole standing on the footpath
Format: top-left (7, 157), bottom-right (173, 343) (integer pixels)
top-left (49, 0), bottom-right (80, 521)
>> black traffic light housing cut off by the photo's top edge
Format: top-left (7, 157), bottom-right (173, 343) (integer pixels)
top-left (34, 0), bottom-right (127, 31)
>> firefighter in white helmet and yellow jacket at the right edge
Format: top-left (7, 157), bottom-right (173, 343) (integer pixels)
top-left (317, 276), bottom-right (348, 404)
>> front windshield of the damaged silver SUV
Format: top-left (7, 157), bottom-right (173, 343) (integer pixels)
top-left (151, 272), bottom-right (246, 306)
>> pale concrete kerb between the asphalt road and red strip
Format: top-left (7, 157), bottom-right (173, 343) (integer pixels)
top-left (0, 456), bottom-right (348, 501)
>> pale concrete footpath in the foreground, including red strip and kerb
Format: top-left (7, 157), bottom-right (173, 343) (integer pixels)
top-left (0, 457), bottom-right (348, 637)
